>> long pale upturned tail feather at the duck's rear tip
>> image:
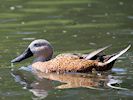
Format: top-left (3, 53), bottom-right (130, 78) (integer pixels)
top-left (98, 45), bottom-right (131, 66)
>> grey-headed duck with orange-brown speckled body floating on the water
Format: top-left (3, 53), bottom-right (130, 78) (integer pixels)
top-left (11, 39), bottom-right (131, 73)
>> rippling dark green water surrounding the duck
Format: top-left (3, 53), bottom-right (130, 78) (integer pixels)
top-left (0, 0), bottom-right (133, 100)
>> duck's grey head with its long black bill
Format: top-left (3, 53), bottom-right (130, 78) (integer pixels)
top-left (11, 39), bottom-right (53, 63)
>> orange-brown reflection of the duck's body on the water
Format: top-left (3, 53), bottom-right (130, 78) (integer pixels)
top-left (36, 72), bottom-right (107, 89)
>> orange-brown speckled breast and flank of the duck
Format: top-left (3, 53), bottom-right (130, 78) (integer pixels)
top-left (32, 54), bottom-right (101, 73)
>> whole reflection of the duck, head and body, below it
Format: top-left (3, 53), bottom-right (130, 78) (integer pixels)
top-left (12, 67), bottom-right (124, 99)
